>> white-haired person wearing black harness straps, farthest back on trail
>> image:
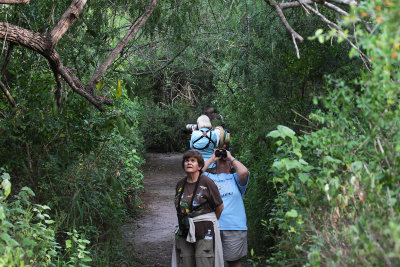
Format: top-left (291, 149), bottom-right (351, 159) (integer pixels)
top-left (190, 115), bottom-right (220, 168)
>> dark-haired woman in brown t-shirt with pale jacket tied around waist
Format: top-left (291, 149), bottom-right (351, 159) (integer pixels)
top-left (172, 150), bottom-right (224, 267)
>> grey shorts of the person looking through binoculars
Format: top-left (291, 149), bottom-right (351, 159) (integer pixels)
top-left (221, 230), bottom-right (247, 261)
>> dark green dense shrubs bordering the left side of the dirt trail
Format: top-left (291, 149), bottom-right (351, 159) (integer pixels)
top-left (0, 85), bottom-right (144, 266)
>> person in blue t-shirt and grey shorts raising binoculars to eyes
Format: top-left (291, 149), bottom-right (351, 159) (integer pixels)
top-left (203, 151), bottom-right (250, 267)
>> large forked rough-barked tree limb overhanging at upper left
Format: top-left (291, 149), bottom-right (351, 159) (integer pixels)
top-left (0, 0), bottom-right (159, 111)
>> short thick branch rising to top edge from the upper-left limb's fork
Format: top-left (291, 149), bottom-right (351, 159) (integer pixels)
top-left (50, 0), bottom-right (86, 48)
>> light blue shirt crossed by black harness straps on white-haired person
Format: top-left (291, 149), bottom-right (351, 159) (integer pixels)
top-left (190, 128), bottom-right (218, 168)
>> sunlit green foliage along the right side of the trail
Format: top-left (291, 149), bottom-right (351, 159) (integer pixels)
top-left (260, 1), bottom-right (400, 266)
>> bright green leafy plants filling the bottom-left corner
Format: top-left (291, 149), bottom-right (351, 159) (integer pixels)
top-left (0, 173), bottom-right (91, 266)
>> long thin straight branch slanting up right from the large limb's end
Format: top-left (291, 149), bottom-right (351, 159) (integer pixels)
top-left (87, 0), bottom-right (160, 87)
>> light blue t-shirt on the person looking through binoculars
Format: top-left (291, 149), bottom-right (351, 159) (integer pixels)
top-left (204, 172), bottom-right (250, 230)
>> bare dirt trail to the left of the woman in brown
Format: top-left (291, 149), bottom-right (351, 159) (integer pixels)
top-left (124, 153), bottom-right (185, 267)
